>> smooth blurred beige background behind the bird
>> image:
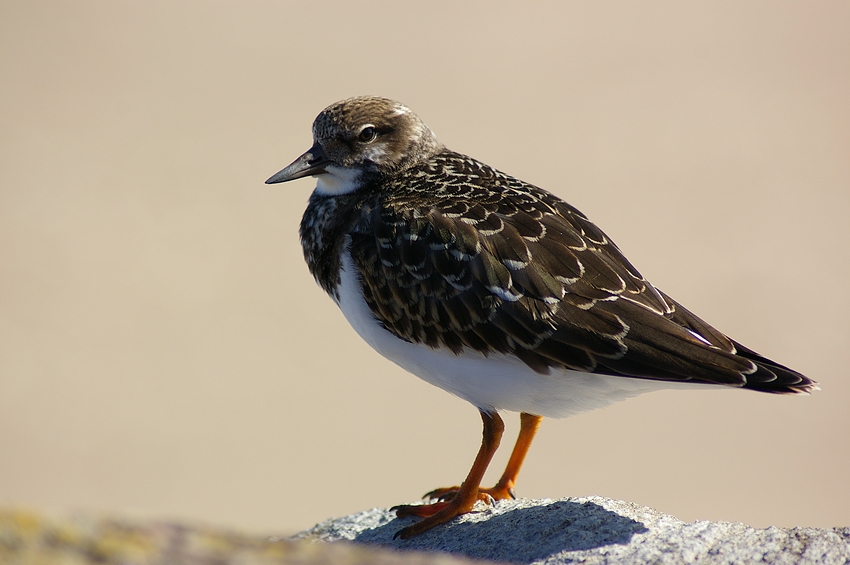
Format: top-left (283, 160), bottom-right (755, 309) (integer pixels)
top-left (0, 0), bottom-right (850, 533)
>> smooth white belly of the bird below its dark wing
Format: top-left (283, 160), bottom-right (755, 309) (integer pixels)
top-left (339, 250), bottom-right (709, 418)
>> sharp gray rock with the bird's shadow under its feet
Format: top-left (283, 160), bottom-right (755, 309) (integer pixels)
top-left (295, 496), bottom-right (850, 565)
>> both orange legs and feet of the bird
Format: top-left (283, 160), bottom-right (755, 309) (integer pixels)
top-left (392, 412), bottom-right (543, 538)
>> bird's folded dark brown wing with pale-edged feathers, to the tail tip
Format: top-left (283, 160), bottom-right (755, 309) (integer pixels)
top-left (350, 152), bottom-right (811, 392)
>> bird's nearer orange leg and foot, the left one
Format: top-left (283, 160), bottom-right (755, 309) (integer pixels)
top-left (392, 411), bottom-right (505, 539)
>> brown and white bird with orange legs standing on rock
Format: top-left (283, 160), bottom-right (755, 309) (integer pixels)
top-left (266, 96), bottom-right (818, 538)
